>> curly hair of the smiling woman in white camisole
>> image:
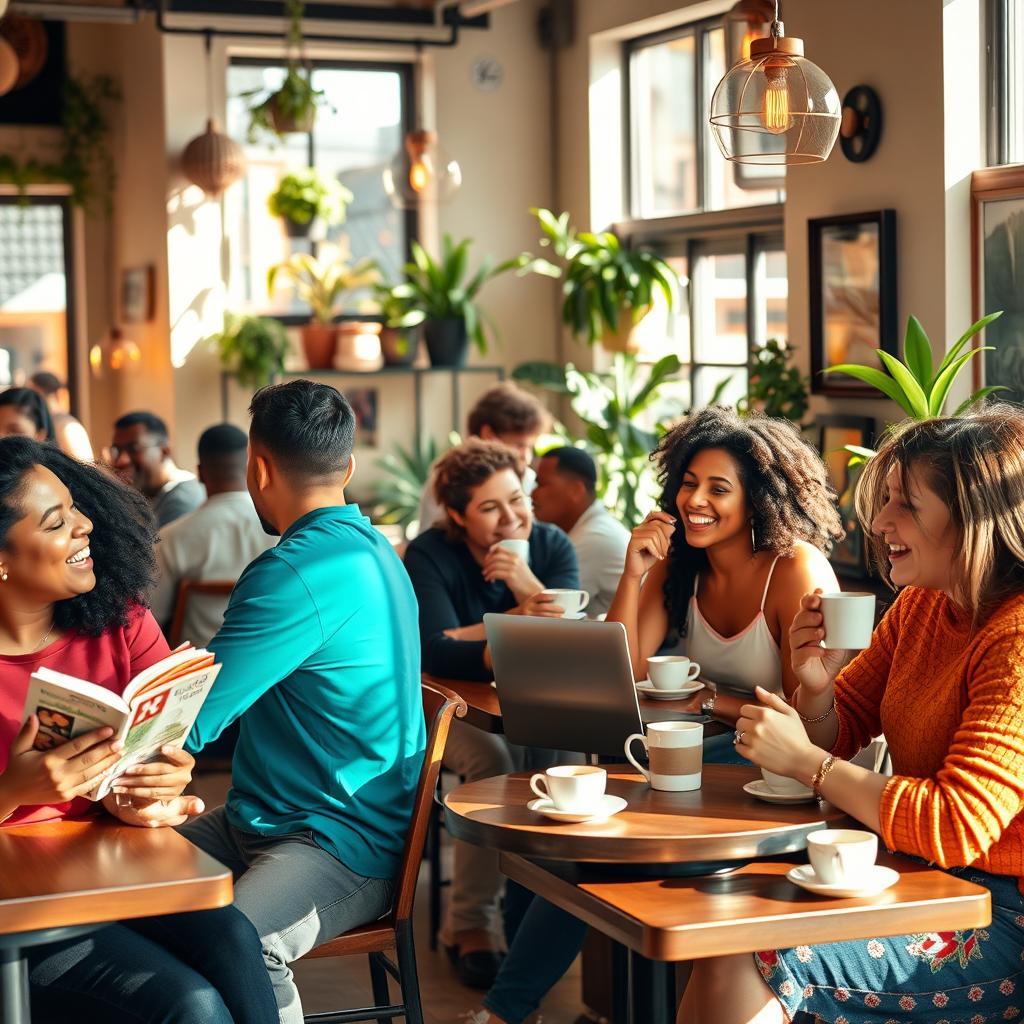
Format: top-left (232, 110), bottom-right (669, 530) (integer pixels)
top-left (650, 408), bottom-right (844, 636)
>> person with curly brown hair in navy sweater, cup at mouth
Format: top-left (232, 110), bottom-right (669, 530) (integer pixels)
top-left (406, 438), bottom-right (580, 988)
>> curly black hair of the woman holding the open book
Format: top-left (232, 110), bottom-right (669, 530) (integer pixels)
top-left (0, 437), bottom-right (157, 636)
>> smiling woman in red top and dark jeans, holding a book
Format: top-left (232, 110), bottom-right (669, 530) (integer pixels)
top-left (0, 437), bottom-right (278, 1024)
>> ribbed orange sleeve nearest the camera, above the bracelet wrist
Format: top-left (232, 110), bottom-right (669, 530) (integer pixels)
top-left (880, 621), bottom-right (1024, 867)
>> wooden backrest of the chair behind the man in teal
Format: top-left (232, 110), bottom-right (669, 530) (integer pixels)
top-left (391, 683), bottom-right (467, 926)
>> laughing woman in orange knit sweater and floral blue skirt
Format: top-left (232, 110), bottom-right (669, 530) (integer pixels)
top-left (679, 406), bottom-right (1024, 1024)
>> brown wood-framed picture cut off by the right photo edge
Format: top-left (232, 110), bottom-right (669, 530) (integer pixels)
top-left (971, 164), bottom-right (1024, 402)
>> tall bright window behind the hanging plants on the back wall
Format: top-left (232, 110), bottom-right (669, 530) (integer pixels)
top-left (224, 58), bottom-right (416, 322)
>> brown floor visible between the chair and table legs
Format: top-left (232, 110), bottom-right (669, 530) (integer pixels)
top-left (190, 773), bottom-right (584, 1024)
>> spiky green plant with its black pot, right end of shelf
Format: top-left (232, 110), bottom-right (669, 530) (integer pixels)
top-left (392, 234), bottom-right (543, 367)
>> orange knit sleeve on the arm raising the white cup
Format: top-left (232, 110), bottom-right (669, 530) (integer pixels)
top-left (831, 591), bottom-right (907, 759)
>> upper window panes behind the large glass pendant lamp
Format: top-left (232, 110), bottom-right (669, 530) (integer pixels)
top-left (625, 19), bottom-right (785, 220)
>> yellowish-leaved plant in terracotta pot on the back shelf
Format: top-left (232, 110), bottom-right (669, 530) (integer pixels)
top-left (266, 253), bottom-right (380, 370)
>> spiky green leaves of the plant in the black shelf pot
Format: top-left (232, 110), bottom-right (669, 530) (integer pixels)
top-left (391, 234), bottom-right (535, 353)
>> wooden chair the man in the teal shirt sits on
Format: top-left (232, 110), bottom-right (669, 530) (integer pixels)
top-left (305, 683), bottom-right (466, 1024)
